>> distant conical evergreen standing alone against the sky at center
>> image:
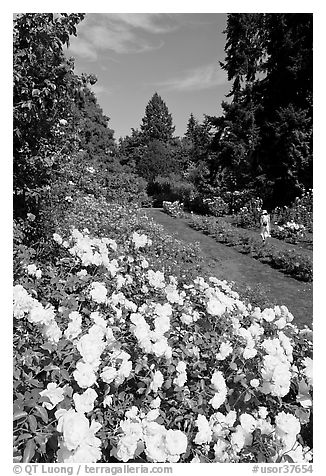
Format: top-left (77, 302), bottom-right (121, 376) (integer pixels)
top-left (140, 93), bottom-right (175, 144)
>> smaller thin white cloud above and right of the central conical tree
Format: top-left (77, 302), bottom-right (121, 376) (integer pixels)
top-left (157, 62), bottom-right (228, 91)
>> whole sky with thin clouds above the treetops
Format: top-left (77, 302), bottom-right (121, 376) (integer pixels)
top-left (68, 13), bottom-right (230, 139)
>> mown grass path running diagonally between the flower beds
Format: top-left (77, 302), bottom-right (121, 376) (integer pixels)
top-left (145, 208), bottom-right (312, 326)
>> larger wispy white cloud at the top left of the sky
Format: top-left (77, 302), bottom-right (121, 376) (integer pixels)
top-left (65, 13), bottom-right (176, 61)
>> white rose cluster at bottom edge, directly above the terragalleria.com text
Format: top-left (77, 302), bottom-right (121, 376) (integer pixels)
top-left (111, 406), bottom-right (188, 463)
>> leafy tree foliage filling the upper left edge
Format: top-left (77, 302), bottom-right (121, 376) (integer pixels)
top-left (13, 13), bottom-right (86, 216)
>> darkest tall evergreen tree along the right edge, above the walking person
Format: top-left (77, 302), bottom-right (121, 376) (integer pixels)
top-left (260, 13), bottom-right (313, 202)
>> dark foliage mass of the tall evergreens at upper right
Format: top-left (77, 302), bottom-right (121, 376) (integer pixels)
top-left (209, 13), bottom-right (312, 208)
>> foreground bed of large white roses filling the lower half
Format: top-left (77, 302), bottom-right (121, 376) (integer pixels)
top-left (14, 230), bottom-right (312, 463)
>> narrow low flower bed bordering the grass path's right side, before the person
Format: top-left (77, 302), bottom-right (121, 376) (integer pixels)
top-left (188, 214), bottom-right (313, 281)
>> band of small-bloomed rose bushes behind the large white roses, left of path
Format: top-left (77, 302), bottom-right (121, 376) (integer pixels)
top-left (27, 195), bottom-right (202, 278)
